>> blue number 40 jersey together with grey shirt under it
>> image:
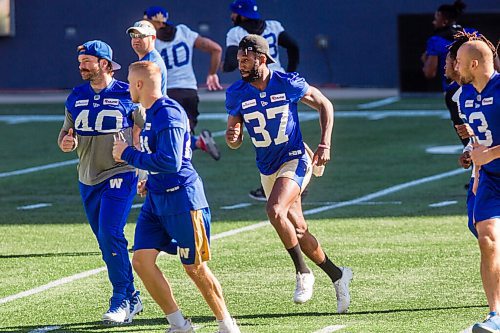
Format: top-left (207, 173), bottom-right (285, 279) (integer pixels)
top-left (62, 79), bottom-right (145, 185)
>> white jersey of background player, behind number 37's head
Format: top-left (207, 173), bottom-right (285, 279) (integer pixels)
top-left (226, 20), bottom-right (285, 72)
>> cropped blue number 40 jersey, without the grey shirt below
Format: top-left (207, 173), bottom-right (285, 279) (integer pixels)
top-left (66, 79), bottom-right (137, 136)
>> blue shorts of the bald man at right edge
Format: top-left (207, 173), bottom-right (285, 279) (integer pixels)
top-left (474, 169), bottom-right (500, 223)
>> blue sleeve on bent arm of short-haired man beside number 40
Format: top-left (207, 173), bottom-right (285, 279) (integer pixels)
top-left (122, 127), bottom-right (185, 173)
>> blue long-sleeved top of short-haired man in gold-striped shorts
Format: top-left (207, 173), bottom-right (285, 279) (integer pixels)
top-left (122, 97), bottom-right (198, 193)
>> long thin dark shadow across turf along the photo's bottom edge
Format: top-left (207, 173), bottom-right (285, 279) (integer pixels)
top-left (0, 305), bottom-right (488, 333)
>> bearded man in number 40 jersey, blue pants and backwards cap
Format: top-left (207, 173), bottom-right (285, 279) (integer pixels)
top-left (58, 40), bottom-right (144, 324)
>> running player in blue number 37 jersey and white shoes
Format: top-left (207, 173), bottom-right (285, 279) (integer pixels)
top-left (226, 35), bottom-right (352, 313)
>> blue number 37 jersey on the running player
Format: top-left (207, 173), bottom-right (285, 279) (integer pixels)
top-left (226, 71), bottom-right (309, 175)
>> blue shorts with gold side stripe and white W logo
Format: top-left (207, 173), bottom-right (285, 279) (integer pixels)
top-left (134, 200), bottom-right (211, 265)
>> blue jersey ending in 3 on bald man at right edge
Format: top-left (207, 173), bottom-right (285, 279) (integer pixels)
top-left (460, 72), bottom-right (500, 177)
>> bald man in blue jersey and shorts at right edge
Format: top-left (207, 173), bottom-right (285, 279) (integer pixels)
top-left (457, 34), bottom-right (500, 333)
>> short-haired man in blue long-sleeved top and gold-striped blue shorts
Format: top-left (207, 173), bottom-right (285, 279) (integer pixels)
top-left (113, 61), bottom-right (240, 333)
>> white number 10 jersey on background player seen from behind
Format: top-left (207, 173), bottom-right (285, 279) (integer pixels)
top-left (155, 24), bottom-right (199, 89)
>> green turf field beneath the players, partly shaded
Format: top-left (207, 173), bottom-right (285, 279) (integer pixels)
top-left (0, 98), bottom-right (488, 333)
